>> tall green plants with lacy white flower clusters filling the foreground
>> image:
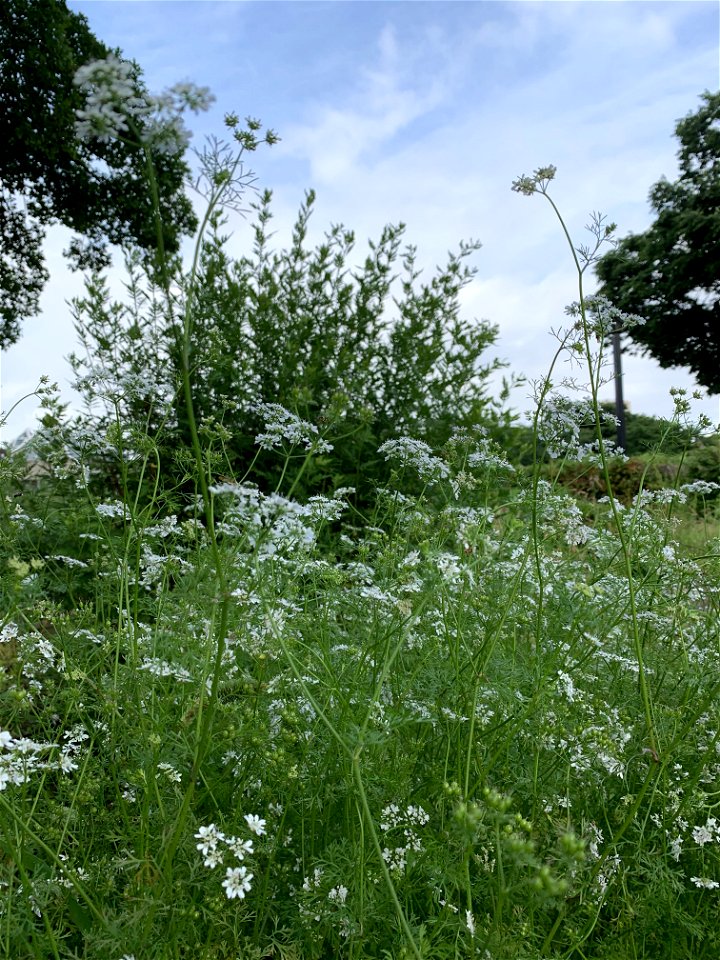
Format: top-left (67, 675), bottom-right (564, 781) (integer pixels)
top-left (0, 127), bottom-right (720, 960)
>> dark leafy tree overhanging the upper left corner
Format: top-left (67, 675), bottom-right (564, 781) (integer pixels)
top-left (0, 0), bottom-right (197, 347)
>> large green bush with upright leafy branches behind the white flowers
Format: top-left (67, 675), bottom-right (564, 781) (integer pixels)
top-left (66, 192), bottom-right (501, 506)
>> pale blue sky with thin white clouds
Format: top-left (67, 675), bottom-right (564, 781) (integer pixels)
top-left (0, 0), bottom-right (720, 439)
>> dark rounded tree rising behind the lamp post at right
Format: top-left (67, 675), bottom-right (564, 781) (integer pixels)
top-left (596, 91), bottom-right (720, 393)
